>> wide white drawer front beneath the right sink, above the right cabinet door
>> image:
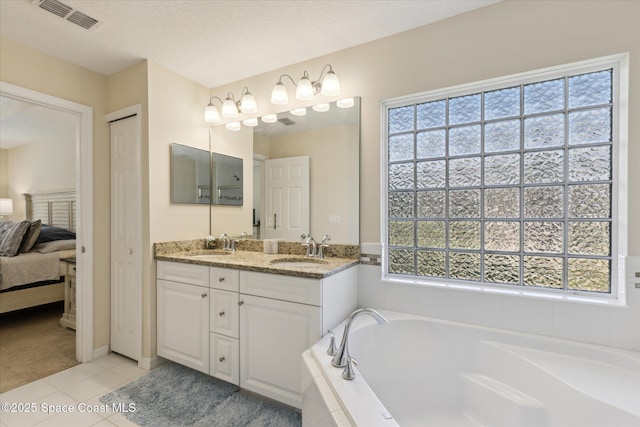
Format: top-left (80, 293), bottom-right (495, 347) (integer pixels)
top-left (240, 271), bottom-right (322, 306)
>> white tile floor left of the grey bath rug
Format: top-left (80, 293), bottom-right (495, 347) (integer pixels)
top-left (0, 354), bottom-right (148, 427)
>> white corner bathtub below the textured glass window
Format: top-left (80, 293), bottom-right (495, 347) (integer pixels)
top-left (302, 310), bottom-right (640, 427)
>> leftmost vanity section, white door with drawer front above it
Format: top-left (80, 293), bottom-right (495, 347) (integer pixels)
top-left (156, 261), bottom-right (209, 374)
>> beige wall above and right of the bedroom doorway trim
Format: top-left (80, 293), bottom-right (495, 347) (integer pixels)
top-left (0, 38), bottom-right (109, 348)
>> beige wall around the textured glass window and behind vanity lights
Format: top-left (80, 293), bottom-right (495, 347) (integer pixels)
top-left (211, 1), bottom-right (640, 255)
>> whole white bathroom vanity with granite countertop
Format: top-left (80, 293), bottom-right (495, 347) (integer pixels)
top-left (156, 244), bottom-right (358, 408)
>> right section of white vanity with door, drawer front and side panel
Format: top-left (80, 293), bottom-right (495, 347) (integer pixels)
top-left (240, 268), bottom-right (357, 408)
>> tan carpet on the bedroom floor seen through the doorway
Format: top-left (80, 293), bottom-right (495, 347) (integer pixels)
top-left (0, 303), bottom-right (78, 393)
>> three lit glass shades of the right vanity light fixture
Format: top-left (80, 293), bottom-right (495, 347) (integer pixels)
top-left (271, 64), bottom-right (340, 105)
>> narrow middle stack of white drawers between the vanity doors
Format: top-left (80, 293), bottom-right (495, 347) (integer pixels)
top-left (209, 267), bottom-right (240, 385)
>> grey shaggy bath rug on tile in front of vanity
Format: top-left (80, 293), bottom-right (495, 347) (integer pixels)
top-left (100, 362), bottom-right (302, 427)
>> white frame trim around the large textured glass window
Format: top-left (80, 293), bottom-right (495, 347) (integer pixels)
top-left (380, 53), bottom-right (629, 306)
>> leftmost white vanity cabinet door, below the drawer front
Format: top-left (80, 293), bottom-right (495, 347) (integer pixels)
top-left (157, 280), bottom-right (209, 374)
